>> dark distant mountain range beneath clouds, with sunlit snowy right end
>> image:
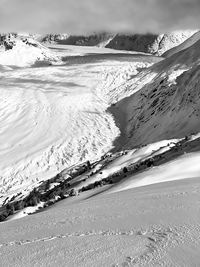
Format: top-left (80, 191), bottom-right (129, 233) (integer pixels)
top-left (40, 30), bottom-right (196, 56)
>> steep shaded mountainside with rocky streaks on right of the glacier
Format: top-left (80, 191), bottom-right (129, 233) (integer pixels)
top-left (113, 41), bottom-right (200, 148)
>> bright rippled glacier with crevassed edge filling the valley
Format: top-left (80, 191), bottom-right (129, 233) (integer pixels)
top-left (0, 45), bottom-right (158, 199)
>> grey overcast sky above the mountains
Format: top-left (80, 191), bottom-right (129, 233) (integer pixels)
top-left (0, 0), bottom-right (200, 34)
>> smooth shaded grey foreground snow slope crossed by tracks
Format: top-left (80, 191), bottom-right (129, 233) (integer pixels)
top-left (0, 176), bottom-right (200, 267)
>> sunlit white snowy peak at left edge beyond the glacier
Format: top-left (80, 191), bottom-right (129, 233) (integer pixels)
top-left (0, 38), bottom-right (59, 67)
